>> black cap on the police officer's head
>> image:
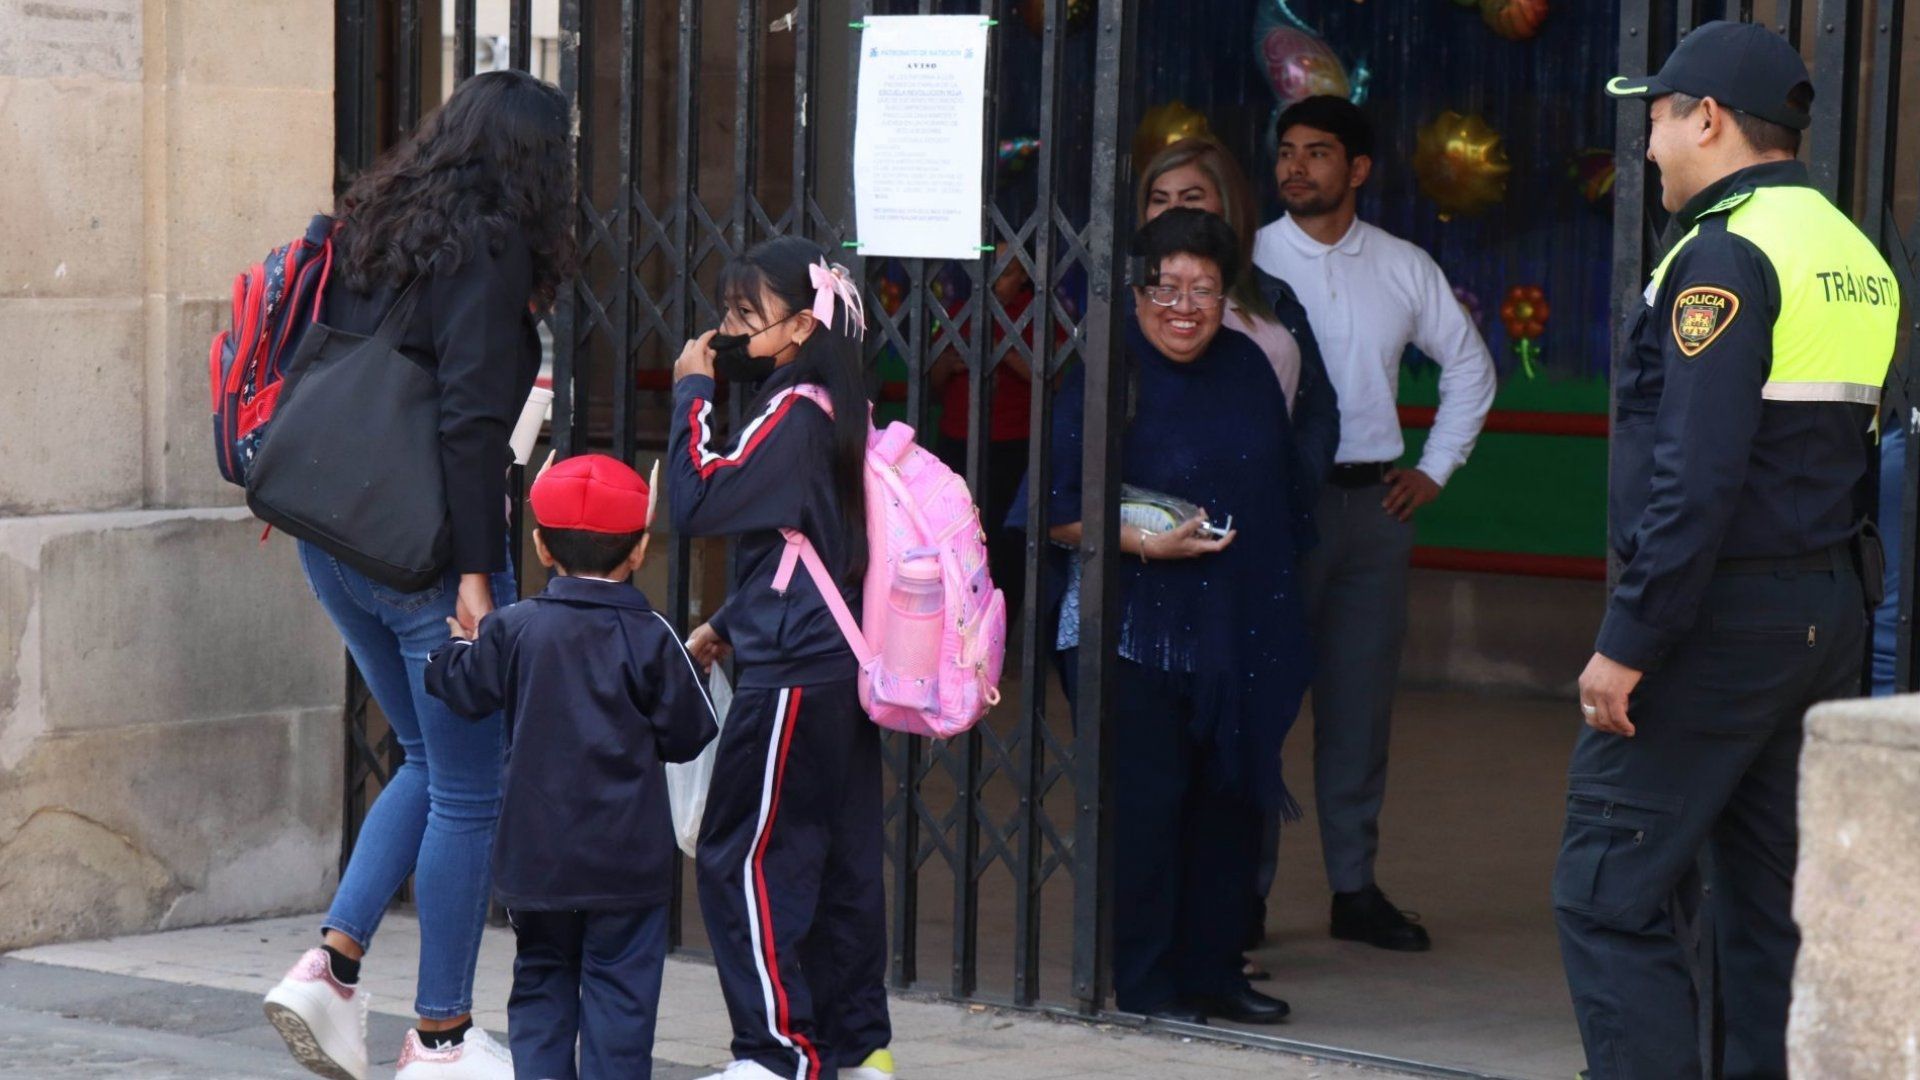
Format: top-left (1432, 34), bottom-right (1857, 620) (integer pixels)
top-left (1607, 21), bottom-right (1812, 131)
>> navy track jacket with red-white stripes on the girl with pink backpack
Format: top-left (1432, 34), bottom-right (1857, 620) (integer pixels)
top-left (666, 365), bottom-right (866, 690)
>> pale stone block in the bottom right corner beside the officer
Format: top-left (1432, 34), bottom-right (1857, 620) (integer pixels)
top-left (1788, 696), bottom-right (1920, 1076)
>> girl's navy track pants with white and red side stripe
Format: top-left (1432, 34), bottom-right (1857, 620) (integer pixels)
top-left (697, 678), bottom-right (893, 1080)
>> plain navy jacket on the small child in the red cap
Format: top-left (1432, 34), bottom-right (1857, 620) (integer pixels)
top-left (426, 577), bottom-right (718, 911)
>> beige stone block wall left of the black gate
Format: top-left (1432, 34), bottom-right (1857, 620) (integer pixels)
top-left (0, 0), bottom-right (344, 949)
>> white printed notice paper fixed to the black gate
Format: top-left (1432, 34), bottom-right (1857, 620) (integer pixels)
top-left (852, 15), bottom-right (987, 259)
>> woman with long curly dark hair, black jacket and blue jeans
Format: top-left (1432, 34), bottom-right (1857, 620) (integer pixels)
top-left (267, 71), bottom-right (574, 1080)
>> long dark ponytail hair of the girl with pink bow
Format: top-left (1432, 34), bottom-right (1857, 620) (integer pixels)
top-left (718, 236), bottom-right (868, 584)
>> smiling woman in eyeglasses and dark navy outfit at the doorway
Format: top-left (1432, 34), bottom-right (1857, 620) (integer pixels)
top-left (1048, 209), bottom-right (1313, 1024)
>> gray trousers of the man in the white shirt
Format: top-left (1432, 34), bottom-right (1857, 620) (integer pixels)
top-left (1254, 484), bottom-right (1413, 897)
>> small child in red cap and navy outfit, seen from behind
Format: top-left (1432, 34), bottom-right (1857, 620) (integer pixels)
top-left (426, 454), bottom-right (718, 1080)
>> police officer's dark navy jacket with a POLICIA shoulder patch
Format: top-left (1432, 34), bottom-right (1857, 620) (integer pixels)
top-left (1596, 161), bottom-right (1874, 671)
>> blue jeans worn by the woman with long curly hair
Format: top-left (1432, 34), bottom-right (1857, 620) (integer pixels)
top-left (300, 544), bottom-right (515, 1020)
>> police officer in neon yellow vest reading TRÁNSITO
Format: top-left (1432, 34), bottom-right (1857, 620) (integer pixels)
top-left (1553, 23), bottom-right (1899, 1080)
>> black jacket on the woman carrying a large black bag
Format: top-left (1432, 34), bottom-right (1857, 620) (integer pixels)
top-left (321, 233), bottom-right (540, 573)
